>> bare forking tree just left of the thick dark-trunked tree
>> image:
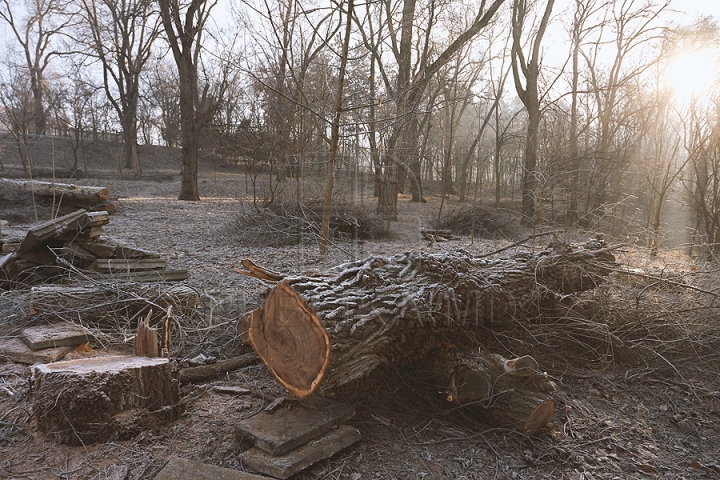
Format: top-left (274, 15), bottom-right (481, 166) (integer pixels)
top-left (82, 0), bottom-right (160, 175)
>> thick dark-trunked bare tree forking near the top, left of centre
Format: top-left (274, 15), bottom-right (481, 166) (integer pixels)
top-left (158, 0), bottom-right (217, 200)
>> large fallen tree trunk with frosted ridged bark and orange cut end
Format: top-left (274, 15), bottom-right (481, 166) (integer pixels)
top-left (237, 238), bottom-right (615, 397)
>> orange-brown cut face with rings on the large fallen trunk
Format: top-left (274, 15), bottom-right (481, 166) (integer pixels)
top-left (241, 281), bottom-right (330, 398)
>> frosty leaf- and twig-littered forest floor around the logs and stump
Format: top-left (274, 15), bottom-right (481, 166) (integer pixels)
top-left (0, 136), bottom-right (720, 480)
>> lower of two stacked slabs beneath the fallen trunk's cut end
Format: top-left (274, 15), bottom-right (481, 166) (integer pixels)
top-left (242, 425), bottom-right (360, 479)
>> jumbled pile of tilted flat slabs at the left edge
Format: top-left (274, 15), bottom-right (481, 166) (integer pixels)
top-left (0, 209), bottom-right (187, 289)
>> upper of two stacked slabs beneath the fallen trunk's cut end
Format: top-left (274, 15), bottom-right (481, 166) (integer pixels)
top-left (235, 396), bottom-right (355, 455)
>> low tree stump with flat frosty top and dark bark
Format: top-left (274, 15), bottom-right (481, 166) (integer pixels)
top-left (33, 356), bottom-right (181, 445)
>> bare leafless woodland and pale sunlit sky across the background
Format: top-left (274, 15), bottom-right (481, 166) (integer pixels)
top-left (0, 0), bottom-right (720, 254)
